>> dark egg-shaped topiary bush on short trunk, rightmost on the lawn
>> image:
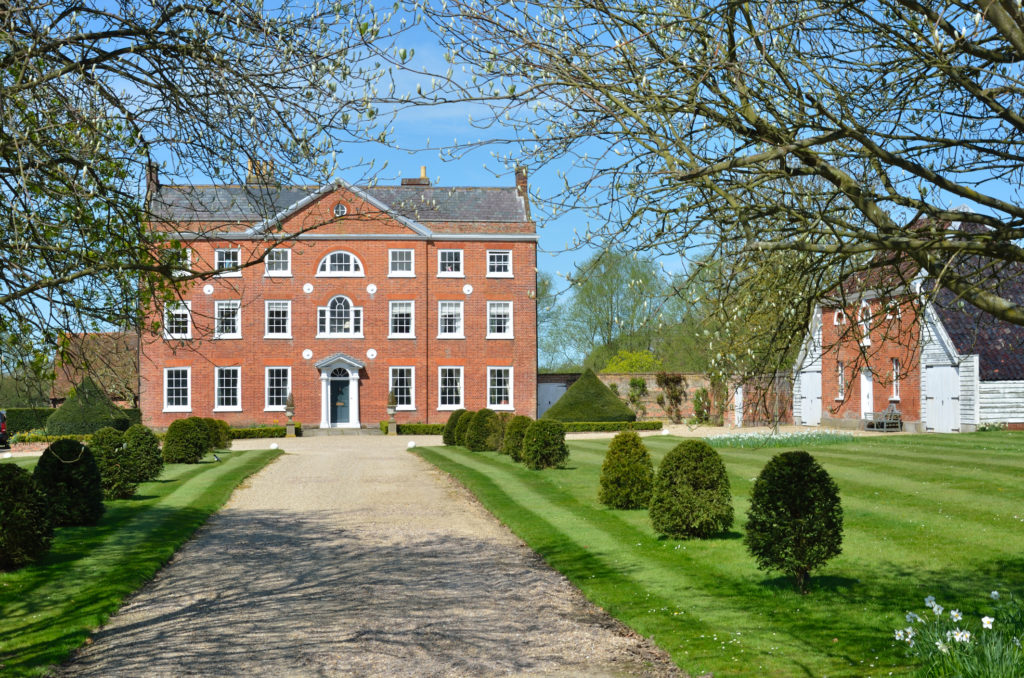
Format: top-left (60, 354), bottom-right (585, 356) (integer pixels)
top-left (744, 451), bottom-right (843, 593)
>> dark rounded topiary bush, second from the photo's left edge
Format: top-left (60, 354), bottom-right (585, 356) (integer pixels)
top-left (32, 438), bottom-right (103, 526)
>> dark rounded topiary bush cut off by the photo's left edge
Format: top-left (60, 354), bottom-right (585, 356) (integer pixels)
top-left (0, 464), bottom-right (53, 569)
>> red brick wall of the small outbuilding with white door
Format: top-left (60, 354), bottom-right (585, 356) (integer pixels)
top-left (821, 299), bottom-right (922, 422)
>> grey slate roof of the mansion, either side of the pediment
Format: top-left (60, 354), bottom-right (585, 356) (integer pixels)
top-left (151, 185), bottom-right (529, 223)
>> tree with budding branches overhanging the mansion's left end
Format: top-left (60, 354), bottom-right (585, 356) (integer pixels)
top-left (0, 0), bottom-right (401, 369)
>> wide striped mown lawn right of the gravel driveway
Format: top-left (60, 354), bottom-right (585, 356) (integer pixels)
top-left (416, 432), bottom-right (1024, 677)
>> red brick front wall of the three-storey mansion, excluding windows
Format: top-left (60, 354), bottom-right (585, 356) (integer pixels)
top-left (140, 180), bottom-right (537, 427)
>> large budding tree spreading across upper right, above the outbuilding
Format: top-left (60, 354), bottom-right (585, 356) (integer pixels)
top-left (417, 0), bottom-right (1024, 373)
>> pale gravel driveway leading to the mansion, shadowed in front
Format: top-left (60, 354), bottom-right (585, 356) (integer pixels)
top-left (61, 435), bottom-right (678, 676)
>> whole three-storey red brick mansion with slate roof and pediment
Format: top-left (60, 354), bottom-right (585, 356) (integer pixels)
top-left (139, 166), bottom-right (537, 428)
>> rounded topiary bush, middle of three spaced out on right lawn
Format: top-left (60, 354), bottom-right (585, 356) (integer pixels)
top-left (650, 440), bottom-right (733, 539)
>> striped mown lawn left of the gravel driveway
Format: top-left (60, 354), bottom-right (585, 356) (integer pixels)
top-left (0, 450), bottom-right (281, 676)
